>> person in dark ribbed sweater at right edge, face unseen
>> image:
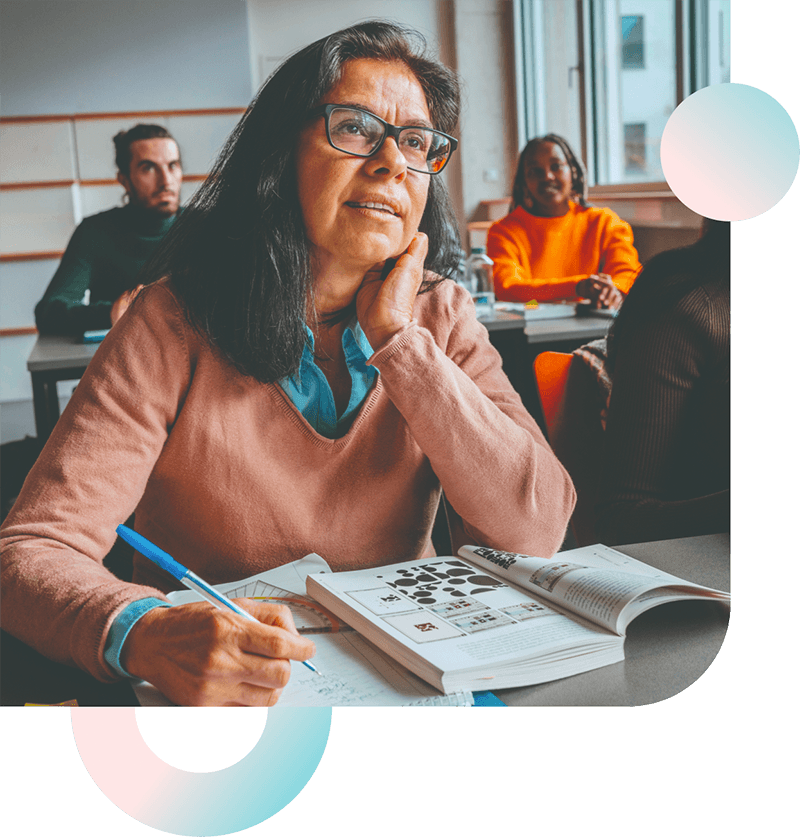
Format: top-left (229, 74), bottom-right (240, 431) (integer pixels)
top-left (595, 219), bottom-right (730, 545)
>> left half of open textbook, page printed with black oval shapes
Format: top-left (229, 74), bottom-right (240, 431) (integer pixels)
top-left (308, 557), bottom-right (622, 688)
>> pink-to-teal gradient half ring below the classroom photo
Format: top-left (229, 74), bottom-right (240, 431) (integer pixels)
top-left (70, 707), bottom-right (332, 837)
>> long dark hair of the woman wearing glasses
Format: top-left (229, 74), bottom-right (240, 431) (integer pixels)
top-left (139, 20), bottom-right (460, 383)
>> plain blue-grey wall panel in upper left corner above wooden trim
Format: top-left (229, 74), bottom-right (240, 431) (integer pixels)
top-left (0, 0), bottom-right (252, 116)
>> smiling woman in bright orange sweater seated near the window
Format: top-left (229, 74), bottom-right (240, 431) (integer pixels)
top-left (487, 134), bottom-right (641, 308)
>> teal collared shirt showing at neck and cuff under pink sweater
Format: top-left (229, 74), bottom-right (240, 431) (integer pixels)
top-left (103, 317), bottom-right (379, 677)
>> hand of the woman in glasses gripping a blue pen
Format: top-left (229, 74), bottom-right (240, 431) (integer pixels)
top-left (121, 599), bottom-right (315, 706)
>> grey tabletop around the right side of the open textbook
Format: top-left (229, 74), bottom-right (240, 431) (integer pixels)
top-left (496, 534), bottom-right (731, 706)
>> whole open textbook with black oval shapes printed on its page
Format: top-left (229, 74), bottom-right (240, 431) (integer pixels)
top-left (306, 545), bottom-right (730, 694)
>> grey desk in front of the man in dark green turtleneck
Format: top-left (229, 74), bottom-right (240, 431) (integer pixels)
top-left (28, 334), bottom-right (99, 441)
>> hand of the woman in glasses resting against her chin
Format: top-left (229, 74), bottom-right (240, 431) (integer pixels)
top-left (356, 232), bottom-right (428, 351)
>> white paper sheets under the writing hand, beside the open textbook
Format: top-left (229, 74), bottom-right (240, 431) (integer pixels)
top-left (128, 554), bottom-right (473, 706)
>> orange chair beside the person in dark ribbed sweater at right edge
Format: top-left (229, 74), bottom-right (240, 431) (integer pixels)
top-left (533, 352), bottom-right (603, 546)
